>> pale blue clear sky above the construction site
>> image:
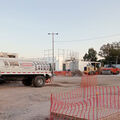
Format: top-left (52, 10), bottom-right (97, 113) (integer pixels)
top-left (0, 0), bottom-right (120, 57)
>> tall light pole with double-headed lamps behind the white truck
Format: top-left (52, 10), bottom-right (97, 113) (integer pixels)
top-left (48, 32), bottom-right (58, 76)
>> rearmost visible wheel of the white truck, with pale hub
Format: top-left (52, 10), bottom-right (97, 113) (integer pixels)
top-left (32, 76), bottom-right (45, 87)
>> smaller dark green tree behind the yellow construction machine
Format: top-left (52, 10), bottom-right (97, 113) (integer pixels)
top-left (83, 48), bottom-right (97, 61)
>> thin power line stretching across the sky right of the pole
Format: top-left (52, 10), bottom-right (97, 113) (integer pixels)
top-left (55, 34), bottom-right (120, 42)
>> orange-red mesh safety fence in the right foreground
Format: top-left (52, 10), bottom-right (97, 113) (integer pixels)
top-left (50, 76), bottom-right (120, 120)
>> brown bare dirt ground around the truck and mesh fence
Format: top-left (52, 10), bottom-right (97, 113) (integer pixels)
top-left (0, 75), bottom-right (120, 120)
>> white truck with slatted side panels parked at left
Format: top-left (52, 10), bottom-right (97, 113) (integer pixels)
top-left (0, 58), bottom-right (52, 87)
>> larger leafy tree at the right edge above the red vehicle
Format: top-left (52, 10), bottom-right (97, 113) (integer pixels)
top-left (99, 42), bottom-right (120, 64)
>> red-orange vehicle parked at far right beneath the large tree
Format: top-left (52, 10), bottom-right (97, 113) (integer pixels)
top-left (101, 65), bottom-right (120, 75)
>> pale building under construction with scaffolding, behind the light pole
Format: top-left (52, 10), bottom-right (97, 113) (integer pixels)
top-left (42, 49), bottom-right (79, 71)
